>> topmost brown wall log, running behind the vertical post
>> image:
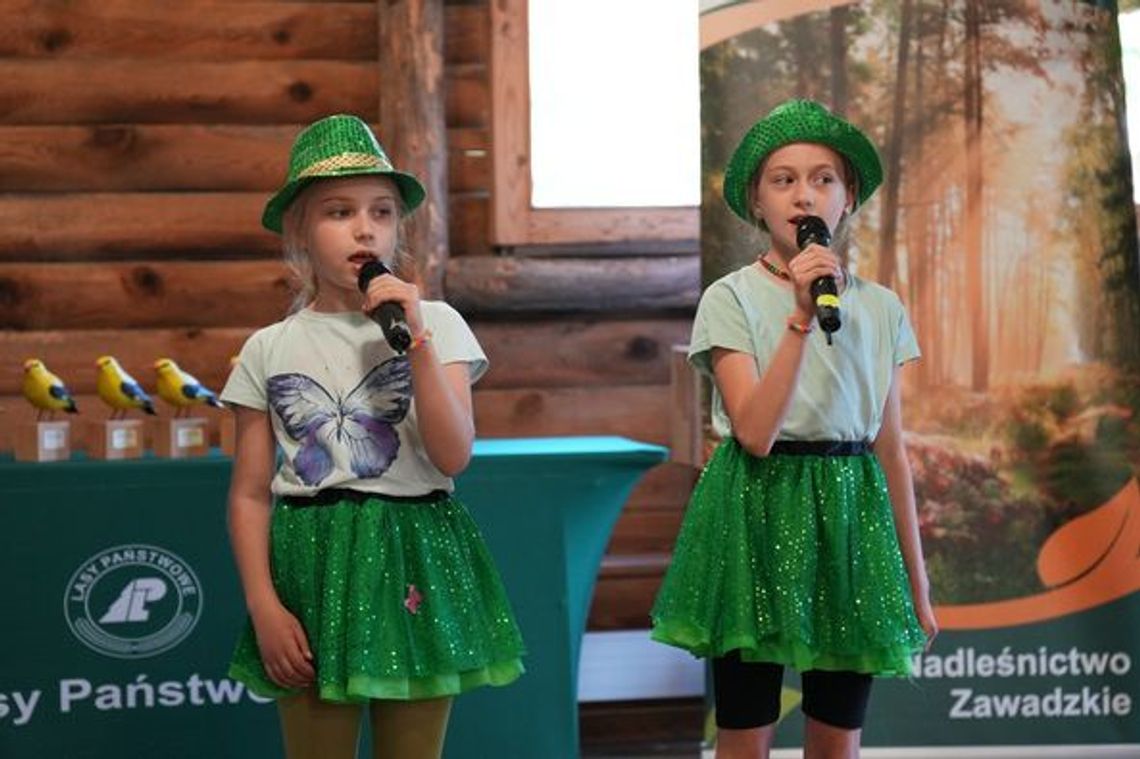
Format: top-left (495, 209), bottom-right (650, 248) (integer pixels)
top-left (0, 0), bottom-right (490, 64)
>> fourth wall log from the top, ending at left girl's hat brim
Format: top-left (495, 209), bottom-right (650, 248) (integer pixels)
top-left (0, 193), bottom-right (271, 259)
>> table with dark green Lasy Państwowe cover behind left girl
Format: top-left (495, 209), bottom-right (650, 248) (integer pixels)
top-left (0, 438), bottom-right (666, 759)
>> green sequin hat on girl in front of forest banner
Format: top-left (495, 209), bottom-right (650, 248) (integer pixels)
top-left (724, 100), bottom-right (882, 223)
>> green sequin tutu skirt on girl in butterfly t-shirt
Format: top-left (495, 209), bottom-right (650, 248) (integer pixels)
top-left (229, 497), bottom-right (523, 701)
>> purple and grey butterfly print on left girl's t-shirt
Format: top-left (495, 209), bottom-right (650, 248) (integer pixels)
top-left (268, 357), bottom-right (412, 485)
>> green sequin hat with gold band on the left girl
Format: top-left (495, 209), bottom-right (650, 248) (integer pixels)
top-left (261, 114), bottom-right (428, 234)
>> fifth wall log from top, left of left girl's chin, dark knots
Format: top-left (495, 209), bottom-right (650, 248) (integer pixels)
top-left (0, 261), bottom-right (290, 330)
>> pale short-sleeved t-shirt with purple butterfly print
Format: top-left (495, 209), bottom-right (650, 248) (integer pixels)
top-left (221, 301), bottom-right (487, 496)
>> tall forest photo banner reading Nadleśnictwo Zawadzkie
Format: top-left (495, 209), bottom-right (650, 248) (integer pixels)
top-left (701, 0), bottom-right (1140, 743)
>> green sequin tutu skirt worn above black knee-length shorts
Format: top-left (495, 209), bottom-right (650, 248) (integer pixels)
top-left (652, 439), bottom-right (926, 676)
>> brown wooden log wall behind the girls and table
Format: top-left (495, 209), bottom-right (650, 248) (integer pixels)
top-left (0, 0), bottom-right (699, 660)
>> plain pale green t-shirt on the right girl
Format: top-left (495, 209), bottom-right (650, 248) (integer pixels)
top-left (689, 266), bottom-right (919, 440)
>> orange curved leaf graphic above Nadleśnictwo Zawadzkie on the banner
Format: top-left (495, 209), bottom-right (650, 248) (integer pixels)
top-left (935, 479), bottom-right (1140, 630)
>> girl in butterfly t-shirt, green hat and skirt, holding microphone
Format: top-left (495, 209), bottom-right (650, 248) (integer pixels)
top-left (222, 115), bottom-right (523, 759)
